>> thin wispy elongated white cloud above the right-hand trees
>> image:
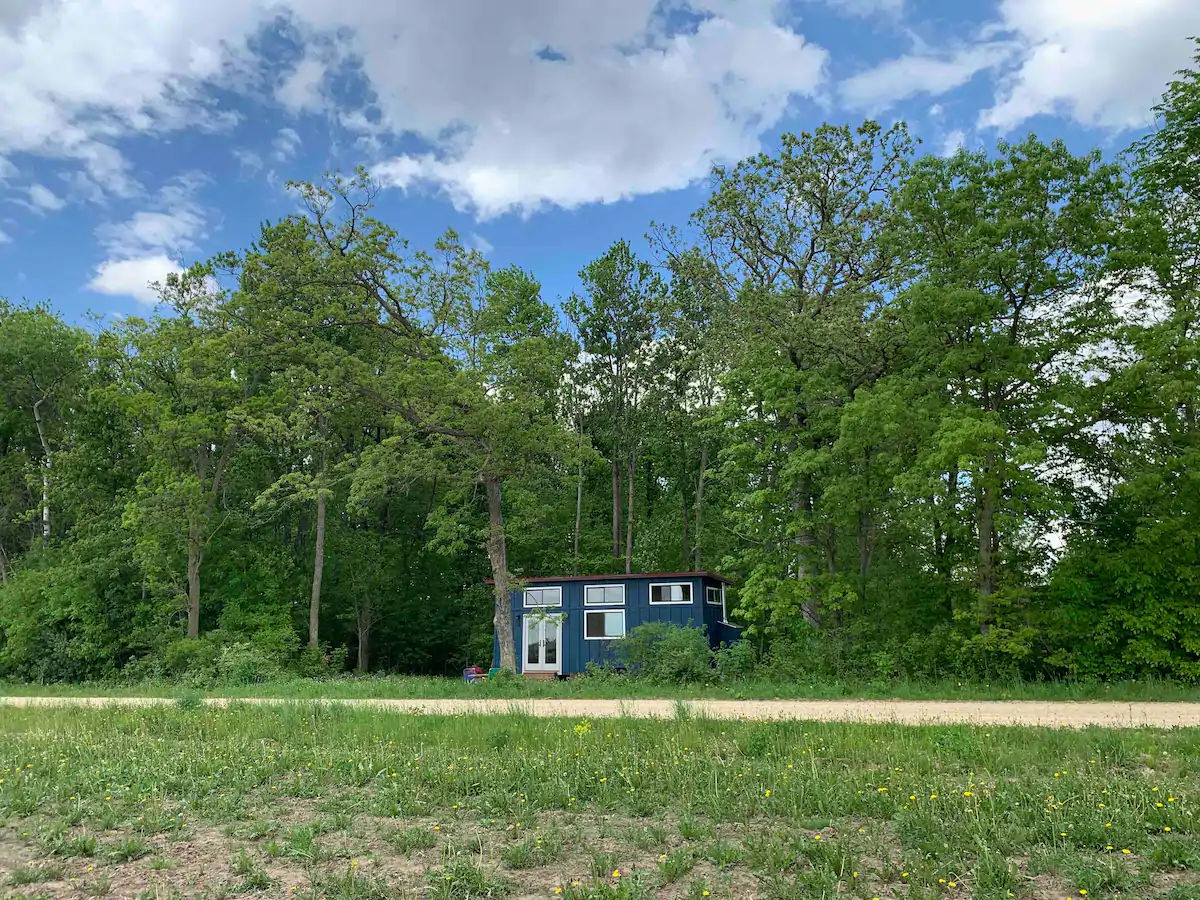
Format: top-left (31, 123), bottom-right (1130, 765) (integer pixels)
top-left (839, 42), bottom-right (1014, 114)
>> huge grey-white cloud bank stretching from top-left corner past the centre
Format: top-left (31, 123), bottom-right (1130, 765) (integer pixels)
top-left (0, 0), bottom-right (828, 216)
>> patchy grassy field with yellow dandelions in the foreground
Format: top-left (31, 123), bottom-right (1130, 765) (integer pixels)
top-left (0, 703), bottom-right (1200, 900)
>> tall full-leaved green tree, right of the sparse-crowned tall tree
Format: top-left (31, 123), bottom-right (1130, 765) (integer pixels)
top-left (900, 138), bottom-right (1124, 635)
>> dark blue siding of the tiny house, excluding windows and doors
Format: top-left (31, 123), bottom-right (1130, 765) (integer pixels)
top-left (492, 576), bottom-right (739, 674)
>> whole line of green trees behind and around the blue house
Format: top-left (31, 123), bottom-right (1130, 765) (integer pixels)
top-left (0, 49), bottom-right (1200, 679)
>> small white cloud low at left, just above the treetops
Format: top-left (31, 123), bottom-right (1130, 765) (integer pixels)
top-left (88, 174), bottom-right (205, 304)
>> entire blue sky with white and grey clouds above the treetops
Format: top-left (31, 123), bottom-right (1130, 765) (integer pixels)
top-left (0, 0), bottom-right (1200, 322)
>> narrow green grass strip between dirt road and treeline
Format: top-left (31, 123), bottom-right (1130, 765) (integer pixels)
top-left (7, 674), bottom-right (1200, 701)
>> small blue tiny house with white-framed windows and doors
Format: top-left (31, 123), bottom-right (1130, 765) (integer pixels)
top-left (492, 572), bottom-right (742, 678)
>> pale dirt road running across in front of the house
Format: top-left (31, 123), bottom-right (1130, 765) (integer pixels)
top-left (0, 697), bottom-right (1200, 728)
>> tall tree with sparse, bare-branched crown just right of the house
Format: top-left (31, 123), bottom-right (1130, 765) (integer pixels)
top-left (694, 122), bottom-right (912, 628)
